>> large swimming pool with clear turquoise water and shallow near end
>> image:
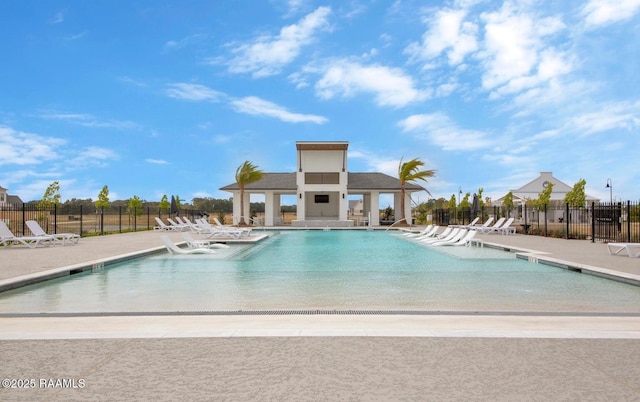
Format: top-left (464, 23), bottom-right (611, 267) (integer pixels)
top-left (0, 230), bottom-right (640, 314)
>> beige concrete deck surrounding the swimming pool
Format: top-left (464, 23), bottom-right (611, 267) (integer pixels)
top-left (0, 228), bottom-right (640, 401)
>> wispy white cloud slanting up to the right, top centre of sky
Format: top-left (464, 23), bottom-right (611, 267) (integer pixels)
top-left (228, 7), bottom-right (331, 78)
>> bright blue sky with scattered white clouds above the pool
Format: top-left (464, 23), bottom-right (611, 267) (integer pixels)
top-left (0, 0), bottom-right (640, 201)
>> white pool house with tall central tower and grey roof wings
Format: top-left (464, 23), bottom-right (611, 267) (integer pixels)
top-left (220, 141), bottom-right (424, 227)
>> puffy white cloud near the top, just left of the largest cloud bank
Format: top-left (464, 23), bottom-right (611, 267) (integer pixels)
top-left (405, 9), bottom-right (478, 66)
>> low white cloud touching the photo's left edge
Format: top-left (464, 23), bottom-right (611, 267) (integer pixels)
top-left (0, 126), bottom-right (66, 166)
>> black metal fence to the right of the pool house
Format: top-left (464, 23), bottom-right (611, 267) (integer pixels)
top-left (432, 201), bottom-right (640, 243)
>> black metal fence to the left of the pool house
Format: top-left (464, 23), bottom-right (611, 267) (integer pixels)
top-left (0, 204), bottom-right (205, 236)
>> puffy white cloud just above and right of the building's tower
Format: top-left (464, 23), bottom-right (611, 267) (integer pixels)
top-left (308, 60), bottom-right (428, 107)
